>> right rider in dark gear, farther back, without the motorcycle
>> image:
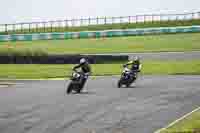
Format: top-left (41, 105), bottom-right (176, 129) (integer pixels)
top-left (123, 56), bottom-right (142, 76)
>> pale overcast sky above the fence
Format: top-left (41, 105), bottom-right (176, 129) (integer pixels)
top-left (0, 0), bottom-right (200, 24)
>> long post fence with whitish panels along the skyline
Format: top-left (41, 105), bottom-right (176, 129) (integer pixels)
top-left (0, 12), bottom-right (200, 34)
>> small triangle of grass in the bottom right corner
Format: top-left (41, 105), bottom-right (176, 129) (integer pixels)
top-left (161, 111), bottom-right (200, 133)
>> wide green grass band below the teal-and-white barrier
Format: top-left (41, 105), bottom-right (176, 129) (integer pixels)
top-left (0, 33), bottom-right (200, 55)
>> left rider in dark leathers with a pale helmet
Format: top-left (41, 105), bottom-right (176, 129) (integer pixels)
top-left (73, 58), bottom-right (91, 89)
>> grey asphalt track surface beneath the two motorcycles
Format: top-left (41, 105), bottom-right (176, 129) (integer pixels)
top-left (0, 76), bottom-right (200, 133)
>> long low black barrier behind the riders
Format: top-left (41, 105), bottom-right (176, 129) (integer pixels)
top-left (0, 55), bottom-right (128, 64)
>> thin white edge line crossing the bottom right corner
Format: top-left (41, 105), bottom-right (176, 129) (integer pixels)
top-left (154, 107), bottom-right (200, 133)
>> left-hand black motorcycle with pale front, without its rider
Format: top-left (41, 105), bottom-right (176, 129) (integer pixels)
top-left (66, 71), bottom-right (88, 94)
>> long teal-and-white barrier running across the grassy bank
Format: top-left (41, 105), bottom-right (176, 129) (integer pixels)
top-left (0, 26), bottom-right (200, 42)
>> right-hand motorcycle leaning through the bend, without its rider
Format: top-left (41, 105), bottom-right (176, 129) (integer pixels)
top-left (118, 67), bottom-right (137, 88)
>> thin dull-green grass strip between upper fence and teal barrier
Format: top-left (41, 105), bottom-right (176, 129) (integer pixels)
top-left (0, 19), bottom-right (200, 34)
